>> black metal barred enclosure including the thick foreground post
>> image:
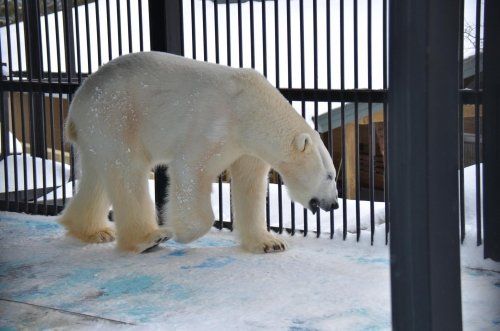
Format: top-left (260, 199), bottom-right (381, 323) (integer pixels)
top-left (0, 0), bottom-right (500, 330)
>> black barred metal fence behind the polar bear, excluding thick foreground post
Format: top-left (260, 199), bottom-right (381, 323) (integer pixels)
top-left (0, 0), bottom-right (492, 248)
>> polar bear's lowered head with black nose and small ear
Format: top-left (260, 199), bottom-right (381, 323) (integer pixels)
top-left (277, 132), bottom-right (339, 213)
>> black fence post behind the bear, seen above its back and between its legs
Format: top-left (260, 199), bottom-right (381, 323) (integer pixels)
top-left (149, 0), bottom-right (184, 218)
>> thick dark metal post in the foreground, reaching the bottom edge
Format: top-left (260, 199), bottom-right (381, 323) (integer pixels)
top-left (388, 0), bottom-right (462, 330)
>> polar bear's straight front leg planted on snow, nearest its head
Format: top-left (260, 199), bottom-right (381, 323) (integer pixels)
top-left (230, 156), bottom-right (288, 253)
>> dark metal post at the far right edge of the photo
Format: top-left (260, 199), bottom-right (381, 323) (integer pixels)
top-left (483, 0), bottom-right (500, 261)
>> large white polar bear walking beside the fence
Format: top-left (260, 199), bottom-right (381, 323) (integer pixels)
top-left (59, 52), bottom-right (338, 252)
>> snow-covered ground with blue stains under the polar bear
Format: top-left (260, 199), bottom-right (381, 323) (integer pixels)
top-left (0, 208), bottom-right (500, 330)
